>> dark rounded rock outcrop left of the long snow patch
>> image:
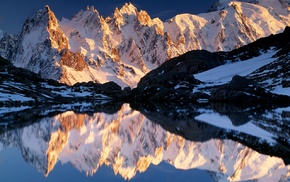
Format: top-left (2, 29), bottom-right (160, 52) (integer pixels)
top-left (133, 50), bottom-right (224, 104)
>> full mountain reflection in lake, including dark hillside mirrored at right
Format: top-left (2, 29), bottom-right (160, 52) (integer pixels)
top-left (0, 104), bottom-right (290, 181)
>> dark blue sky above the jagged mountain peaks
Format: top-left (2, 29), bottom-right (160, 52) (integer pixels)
top-left (0, 0), bottom-right (217, 33)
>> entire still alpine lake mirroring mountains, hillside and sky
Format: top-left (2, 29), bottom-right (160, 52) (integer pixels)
top-left (0, 102), bottom-right (290, 182)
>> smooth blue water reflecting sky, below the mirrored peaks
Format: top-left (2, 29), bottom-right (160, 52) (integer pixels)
top-left (0, 148), bottom-right (213, 182)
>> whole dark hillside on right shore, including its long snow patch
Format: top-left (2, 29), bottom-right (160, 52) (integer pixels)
top-left (132, 27), bottom-right (290, 108)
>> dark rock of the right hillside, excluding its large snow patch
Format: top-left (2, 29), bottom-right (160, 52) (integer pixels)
top-left (132, 27), bottom-right (290, 104)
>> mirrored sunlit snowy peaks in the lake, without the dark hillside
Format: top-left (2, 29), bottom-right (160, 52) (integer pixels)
top-left (0, 105), bottom-right (290, 181)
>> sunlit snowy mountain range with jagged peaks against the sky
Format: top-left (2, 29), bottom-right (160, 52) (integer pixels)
top-left (0, 0), bottom-right (290, 87)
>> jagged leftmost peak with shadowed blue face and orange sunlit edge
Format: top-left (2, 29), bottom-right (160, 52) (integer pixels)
top-left (1, 6), bottom-right (85, 84)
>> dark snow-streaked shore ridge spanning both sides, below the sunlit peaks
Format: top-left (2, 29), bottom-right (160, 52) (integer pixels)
top-left (0, 27), bottom-right (290, 106)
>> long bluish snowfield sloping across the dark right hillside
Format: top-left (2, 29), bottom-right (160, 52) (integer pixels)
top-left (194, 50), bottom-right (290, 96)
